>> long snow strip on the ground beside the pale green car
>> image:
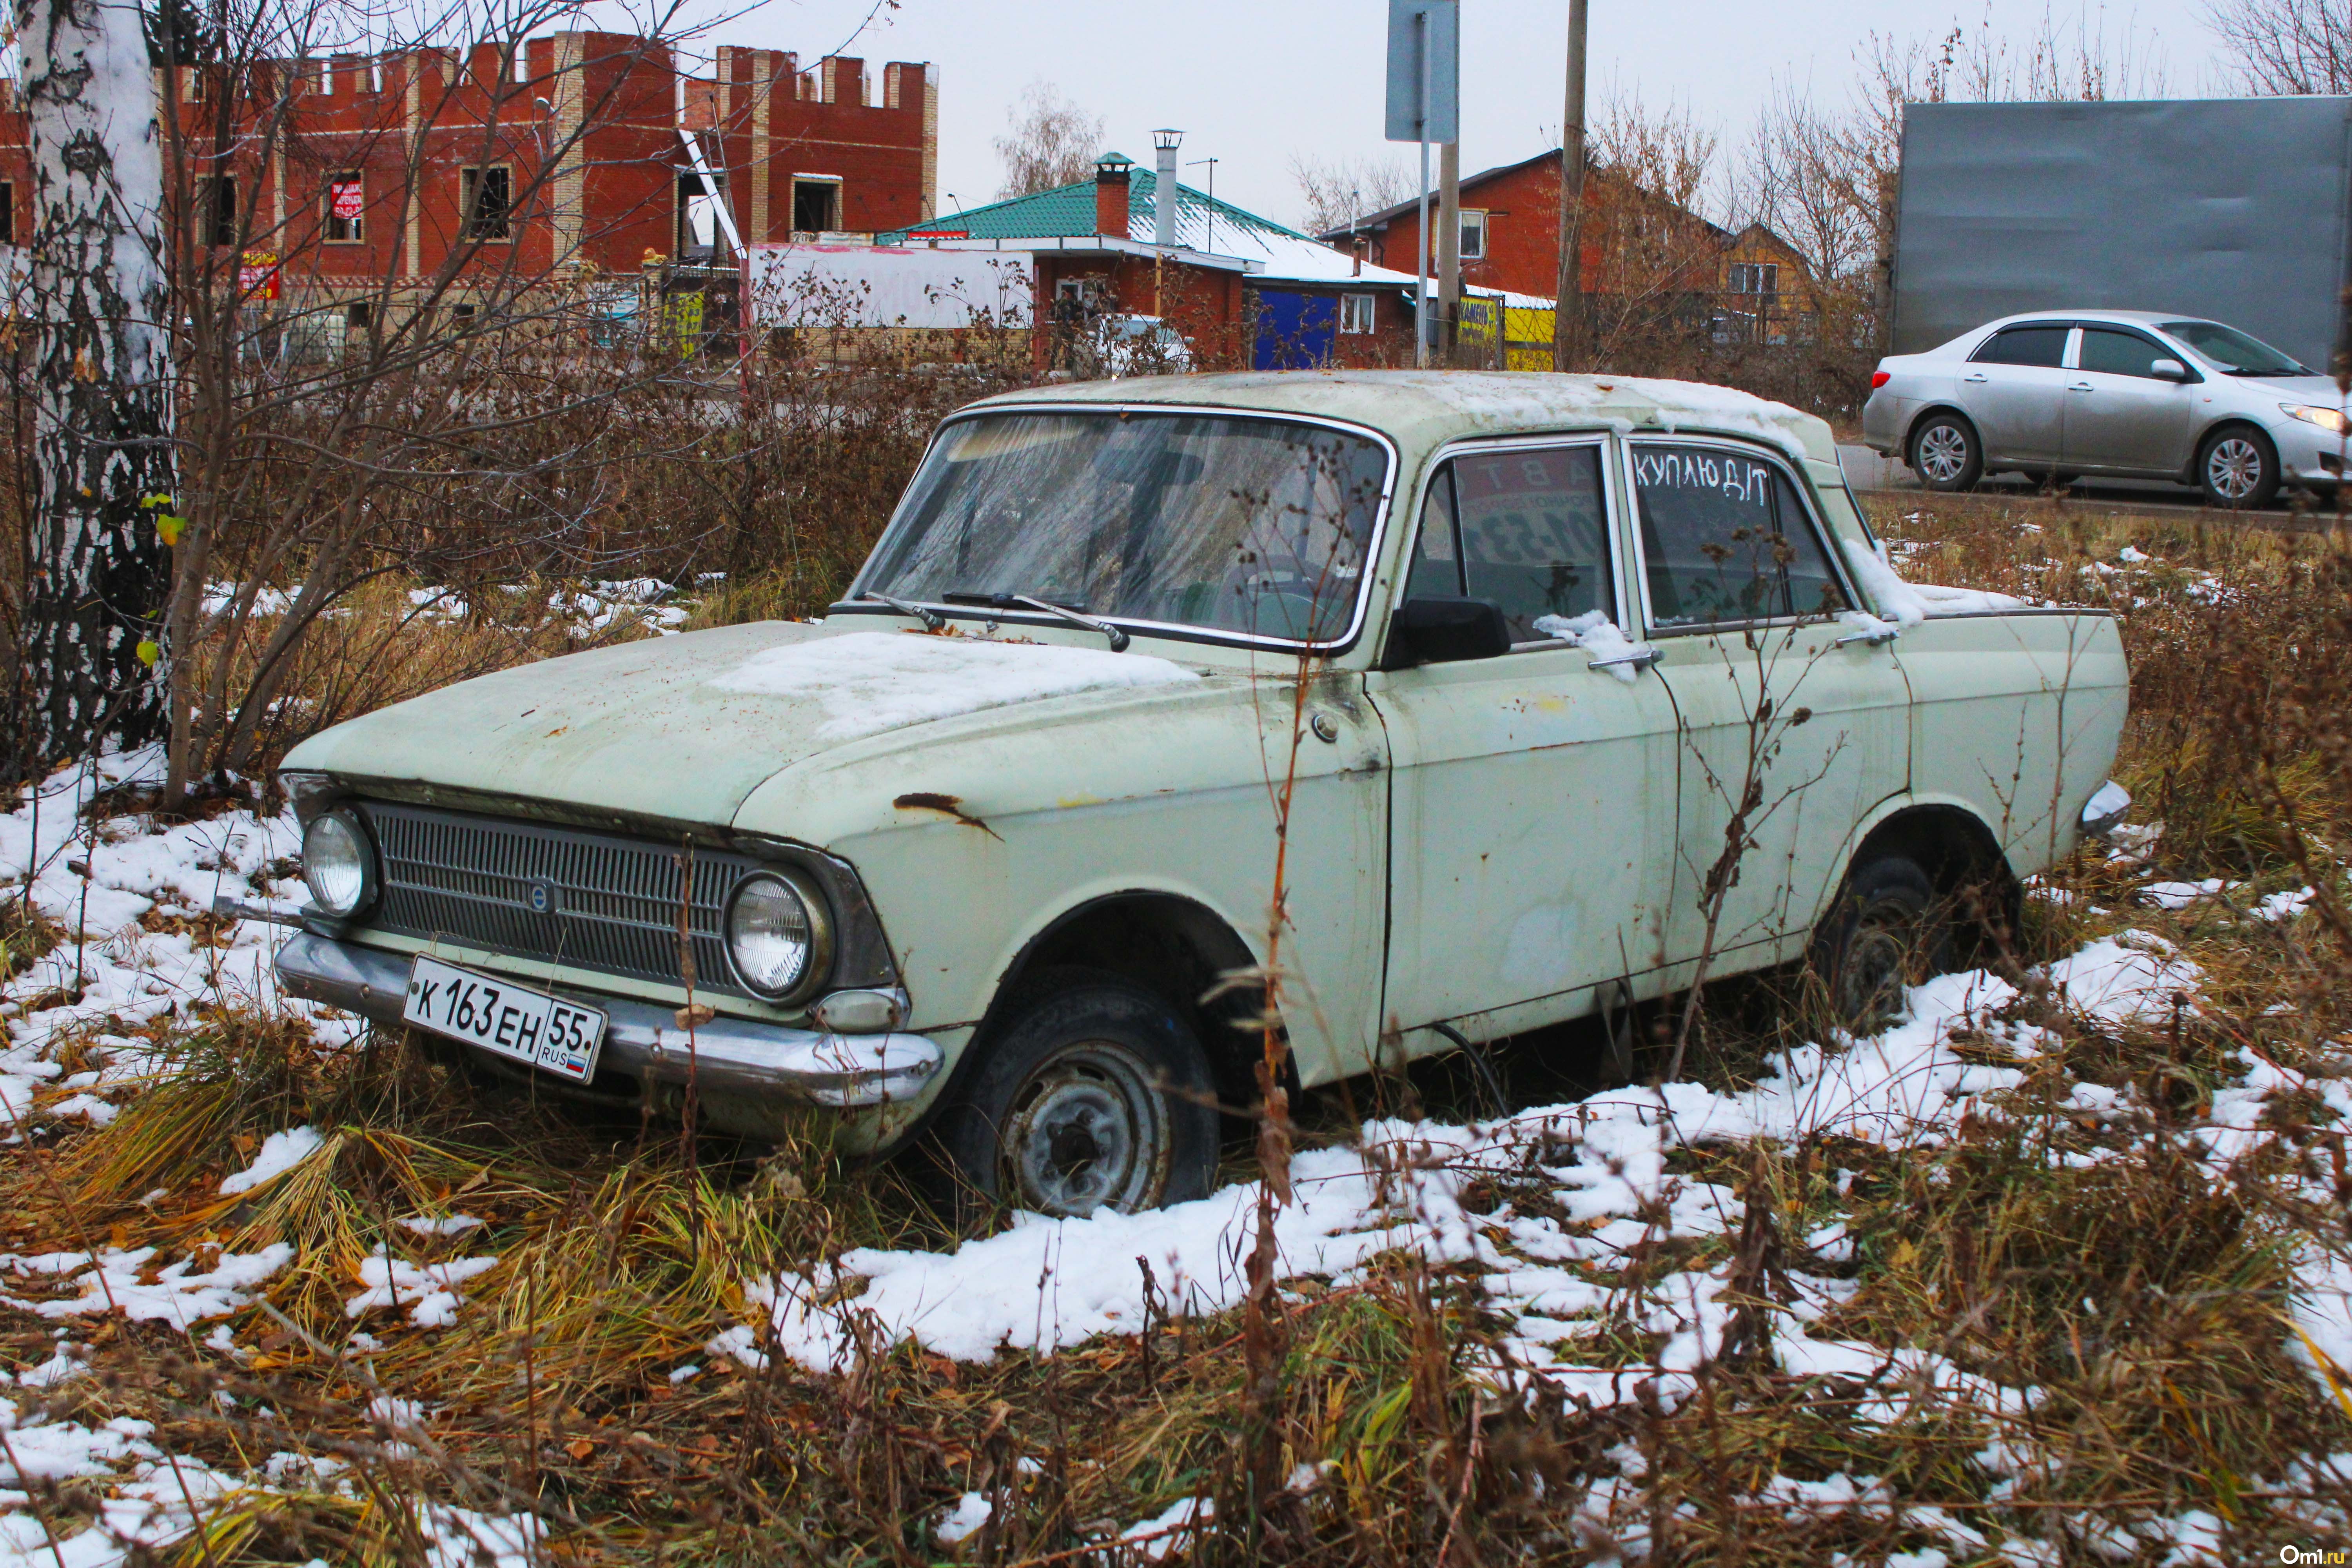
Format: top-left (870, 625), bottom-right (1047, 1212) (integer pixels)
top-left (708, 959), bottom-right (2197, 1406)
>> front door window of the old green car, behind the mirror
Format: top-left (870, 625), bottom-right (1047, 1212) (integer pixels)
top-left (1406, 446), bottom-right (1616, 642)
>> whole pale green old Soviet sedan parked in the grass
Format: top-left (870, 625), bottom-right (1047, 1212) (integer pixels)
top-left (278, 372), bottom-right (2124, 1213)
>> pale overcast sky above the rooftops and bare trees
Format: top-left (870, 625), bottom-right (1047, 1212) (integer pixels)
top-left (621, 0), bottom-right (2216, 223)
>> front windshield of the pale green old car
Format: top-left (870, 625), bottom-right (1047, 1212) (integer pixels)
top-left (858, 409), bottom-right (1388, 642)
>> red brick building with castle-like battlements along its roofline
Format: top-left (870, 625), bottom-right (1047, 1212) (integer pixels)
top-left (0, 33), bottom-right (938, 324)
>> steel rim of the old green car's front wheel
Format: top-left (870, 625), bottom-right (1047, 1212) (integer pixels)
top-left (1002, 1039), bottom-right (1174, 1218)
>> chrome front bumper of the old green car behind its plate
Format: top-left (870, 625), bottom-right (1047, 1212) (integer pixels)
top-left (278, 931), bottom-right (946, 1110)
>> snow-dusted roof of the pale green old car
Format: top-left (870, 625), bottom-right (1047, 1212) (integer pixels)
top-left (971, 369), bottom-right (1837, 463)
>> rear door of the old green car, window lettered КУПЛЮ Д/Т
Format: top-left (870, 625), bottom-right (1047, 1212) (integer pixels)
top-left (1628, 439), bottom-right (1910, 985)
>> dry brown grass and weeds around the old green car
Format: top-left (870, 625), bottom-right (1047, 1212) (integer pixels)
top-left (0, 498), bottom-right (2352, 1568)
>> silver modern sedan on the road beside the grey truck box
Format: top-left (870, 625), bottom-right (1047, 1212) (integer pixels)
top-left (1863, 310), bottom-right (2347, 508)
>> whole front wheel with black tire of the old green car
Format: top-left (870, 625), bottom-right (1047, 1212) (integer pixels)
top-left (941, 969), bottom-right (1218, 1215)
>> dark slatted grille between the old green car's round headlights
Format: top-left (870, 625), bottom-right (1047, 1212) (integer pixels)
top-left (362, 802), bottom-right (757, 997)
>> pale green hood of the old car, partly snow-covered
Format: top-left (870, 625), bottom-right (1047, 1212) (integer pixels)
top-left (285, 621), bottom-right (1200, 823)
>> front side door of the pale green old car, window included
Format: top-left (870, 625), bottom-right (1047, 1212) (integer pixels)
top-left (1367, 437), bottom-right (1675, 1053)
